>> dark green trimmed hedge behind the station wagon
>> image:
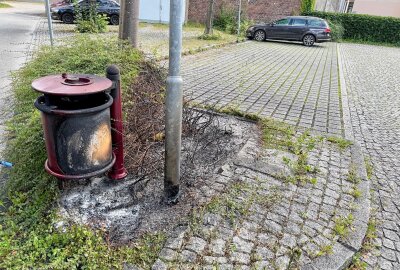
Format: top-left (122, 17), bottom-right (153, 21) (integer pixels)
top-left (303, 11), bottom-right (400, 46)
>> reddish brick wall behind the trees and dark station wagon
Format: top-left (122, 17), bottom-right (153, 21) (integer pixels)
top-left (188, 0), bottom-right (301, 23)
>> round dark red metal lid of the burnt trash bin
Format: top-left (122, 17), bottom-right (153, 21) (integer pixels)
top-left (32, 73), bottom-right (112, 96)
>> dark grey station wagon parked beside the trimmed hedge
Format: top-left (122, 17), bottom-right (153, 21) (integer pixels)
top-left (246, 16), bottom-right (331, 46)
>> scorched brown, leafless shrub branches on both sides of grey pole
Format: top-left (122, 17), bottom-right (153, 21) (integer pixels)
top-left (124, 62), bottom-right (231, 186)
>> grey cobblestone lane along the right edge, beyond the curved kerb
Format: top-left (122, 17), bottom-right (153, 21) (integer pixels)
top-left (340, 44), bottom-right (400, 269)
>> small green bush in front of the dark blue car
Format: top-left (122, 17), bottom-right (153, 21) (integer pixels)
top-left (76, 3), bottom-right (108, 33)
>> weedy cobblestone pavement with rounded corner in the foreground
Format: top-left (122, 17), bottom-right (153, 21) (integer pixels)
top-left (152, 125), bottom-right (368, 270)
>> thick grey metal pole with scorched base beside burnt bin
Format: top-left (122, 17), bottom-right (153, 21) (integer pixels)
top-left (164, 0), bottom-right (183, 203)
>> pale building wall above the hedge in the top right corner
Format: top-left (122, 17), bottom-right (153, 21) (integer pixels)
top-left (353, 0), bottom-right (400, 18)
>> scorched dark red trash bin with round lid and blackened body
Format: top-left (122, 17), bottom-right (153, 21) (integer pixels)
top-left (32, 74), bottom-right (116, 179)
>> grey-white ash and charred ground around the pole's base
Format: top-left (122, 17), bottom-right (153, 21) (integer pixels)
top-left (57, 110), bottom-right (258, 243)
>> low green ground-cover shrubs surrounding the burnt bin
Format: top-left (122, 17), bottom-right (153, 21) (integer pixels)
top-left (0, 36), bottom-right (165, 269)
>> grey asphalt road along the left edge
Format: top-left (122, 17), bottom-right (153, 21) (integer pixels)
top-left (0, 2), bottom-right (44, 179)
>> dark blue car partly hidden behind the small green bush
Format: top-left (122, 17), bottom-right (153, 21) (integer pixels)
top-left (50, 0), bottom-right (120, 25)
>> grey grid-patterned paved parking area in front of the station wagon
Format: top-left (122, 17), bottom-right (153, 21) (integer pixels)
top-left (182, 42), bottom-right (343, 135)
